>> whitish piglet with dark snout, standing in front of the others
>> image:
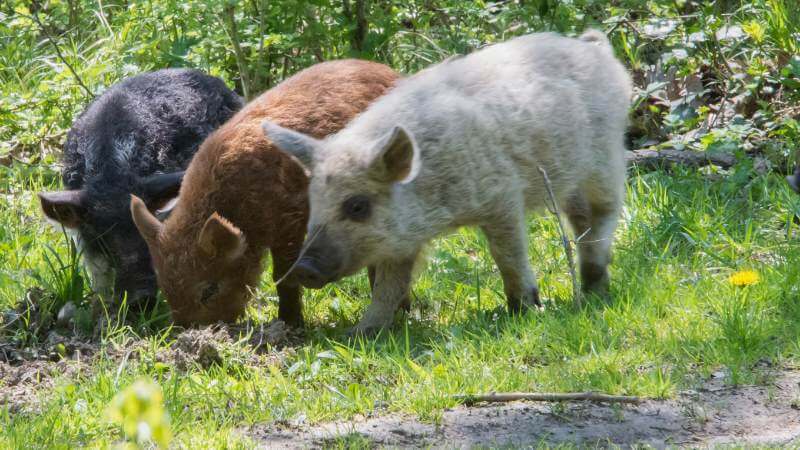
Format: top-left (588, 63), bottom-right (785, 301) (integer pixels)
top-left (264, 31), bottom-right (631, 332)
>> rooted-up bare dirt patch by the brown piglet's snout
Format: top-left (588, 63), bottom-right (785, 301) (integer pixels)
top-left (0, 320), bottom-right (300, 413)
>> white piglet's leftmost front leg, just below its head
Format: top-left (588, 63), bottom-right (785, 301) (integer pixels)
top-left (350, 258), bottom-right (416, 335)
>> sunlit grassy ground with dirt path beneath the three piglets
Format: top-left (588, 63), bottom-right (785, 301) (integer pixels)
top-left (0, 166), bottom-right (800, 448)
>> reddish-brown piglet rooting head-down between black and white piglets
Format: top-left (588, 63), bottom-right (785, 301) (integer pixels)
top-left (131, 60), bottom-right (398, 327)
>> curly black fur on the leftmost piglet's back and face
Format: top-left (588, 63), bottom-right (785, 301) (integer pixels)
top-left (62, 69), bottom-right (242, 306)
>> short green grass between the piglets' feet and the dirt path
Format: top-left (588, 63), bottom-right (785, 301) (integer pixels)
top-left (0, 158), bottom-right (800, 448)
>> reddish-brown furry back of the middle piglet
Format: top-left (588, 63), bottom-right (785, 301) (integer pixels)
top-left (173, 59), bottom-right (398, 232)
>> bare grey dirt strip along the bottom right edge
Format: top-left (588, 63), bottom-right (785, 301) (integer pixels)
top-left (248, 371), bottom-right (800, 449)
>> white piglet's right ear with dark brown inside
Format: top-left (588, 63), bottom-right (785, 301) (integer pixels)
top-left (369, 126), bottom-right (421, 184)
